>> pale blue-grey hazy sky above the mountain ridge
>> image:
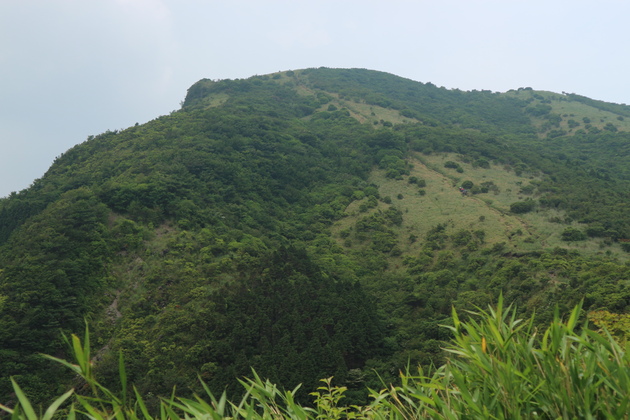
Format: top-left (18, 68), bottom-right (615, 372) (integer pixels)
top-left (0, 0), bottom-right (630, 197)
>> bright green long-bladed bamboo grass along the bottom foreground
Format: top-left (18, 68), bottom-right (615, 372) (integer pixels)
top-left (0, 301), bottom-right (630, 420)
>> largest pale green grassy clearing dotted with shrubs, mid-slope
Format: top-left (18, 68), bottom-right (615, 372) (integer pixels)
top-left (333, 154), bottom-right (629, 261)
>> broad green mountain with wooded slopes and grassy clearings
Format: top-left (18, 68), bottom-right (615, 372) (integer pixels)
top-left (0, 68), bottom-right (630, 404)
